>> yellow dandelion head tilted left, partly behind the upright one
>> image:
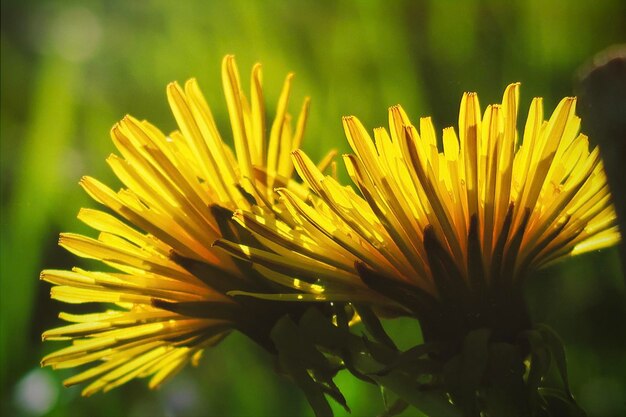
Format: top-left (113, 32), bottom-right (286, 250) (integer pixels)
top-left (41, 56), bottom-right (316, 395)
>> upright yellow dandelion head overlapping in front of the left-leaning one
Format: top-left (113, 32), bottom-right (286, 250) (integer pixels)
top-left (218, 84), bottom-right (620, 338)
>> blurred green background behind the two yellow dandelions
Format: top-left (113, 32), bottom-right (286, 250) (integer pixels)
top-left (0, 0), bottom-right (626, 416)
